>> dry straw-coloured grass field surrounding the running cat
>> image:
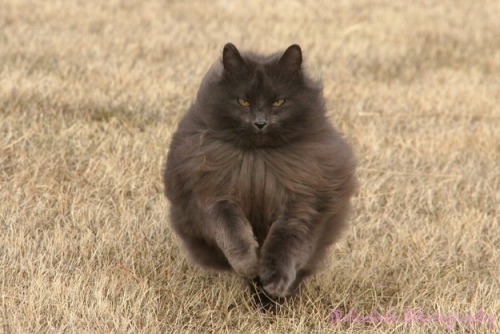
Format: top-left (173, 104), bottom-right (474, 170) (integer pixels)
top-left (0, 0), bottom-right (500, 334)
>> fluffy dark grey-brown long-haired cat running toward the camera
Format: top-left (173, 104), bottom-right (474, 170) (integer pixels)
top-left (164, 43), bottom-right (356, 297)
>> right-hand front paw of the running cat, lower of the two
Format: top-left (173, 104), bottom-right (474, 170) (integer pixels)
top-left (259, 260), bottom-right (297, 297)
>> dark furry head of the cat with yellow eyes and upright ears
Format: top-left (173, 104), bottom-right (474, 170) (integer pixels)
top-left (197, 43), bottom-right (325, 147)
